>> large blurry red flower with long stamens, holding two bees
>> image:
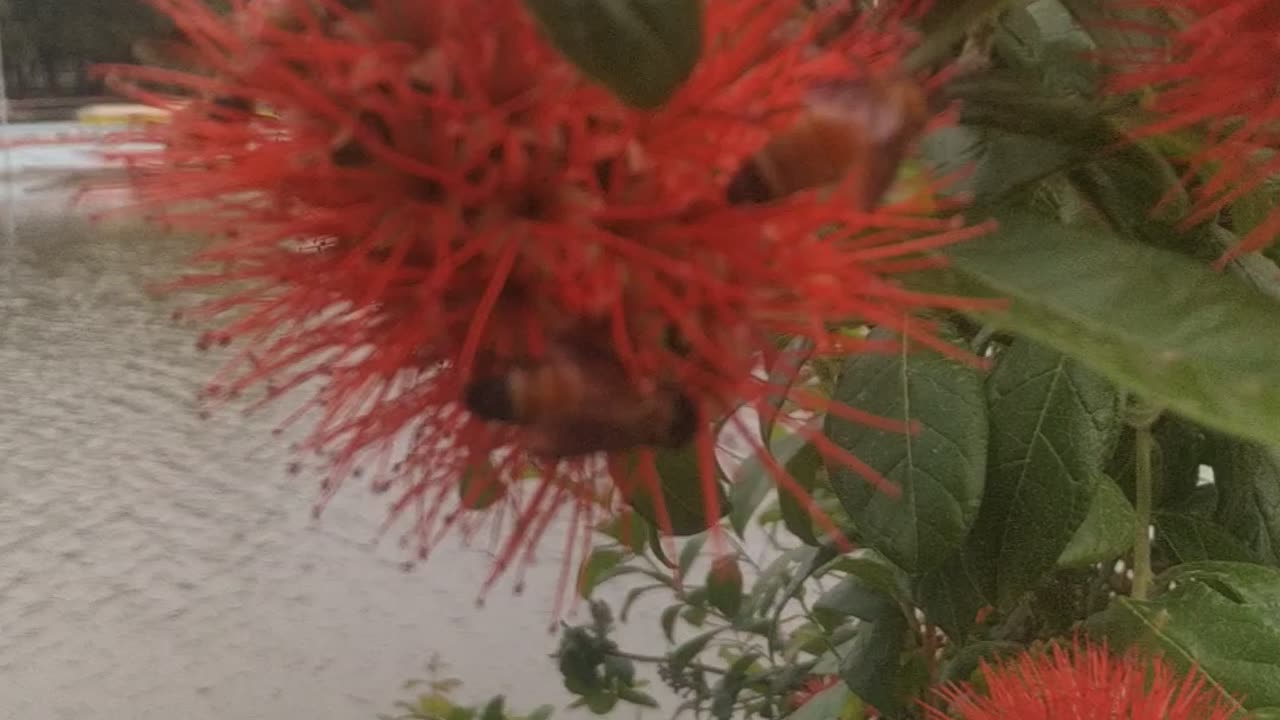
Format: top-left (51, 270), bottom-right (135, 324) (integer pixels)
top-left (97, 0), bottom-right (978, 599)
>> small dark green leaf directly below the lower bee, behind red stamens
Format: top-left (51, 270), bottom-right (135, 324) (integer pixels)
top-left (609, 446), bottom-right (730, 537)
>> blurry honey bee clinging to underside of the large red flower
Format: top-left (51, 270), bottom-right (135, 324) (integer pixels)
top-left (463, 330), bottom-right (699, 457)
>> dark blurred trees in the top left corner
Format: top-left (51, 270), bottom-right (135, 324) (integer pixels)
top-left (0, 0), bottom-right (170, 99)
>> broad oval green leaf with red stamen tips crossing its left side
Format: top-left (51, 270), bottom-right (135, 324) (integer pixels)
top-left (826, 329), bottom-right (987, 573)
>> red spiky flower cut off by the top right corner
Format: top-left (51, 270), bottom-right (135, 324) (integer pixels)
top-left (1110, 0), bottom-right (1280, 263)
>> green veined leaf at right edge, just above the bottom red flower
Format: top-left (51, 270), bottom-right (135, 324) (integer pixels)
top-left (1089, 562), bottom-right (1280, 707)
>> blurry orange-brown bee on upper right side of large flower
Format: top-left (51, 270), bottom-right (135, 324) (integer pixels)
top-left (726, 78), bottom-right (929, 210)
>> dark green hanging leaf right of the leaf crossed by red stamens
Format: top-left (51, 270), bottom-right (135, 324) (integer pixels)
top-left (970, 338), bottom-right (1121, 609)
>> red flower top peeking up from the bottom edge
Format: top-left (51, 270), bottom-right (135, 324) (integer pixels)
top-left (927, 643), bottom-right (1236, 720)
